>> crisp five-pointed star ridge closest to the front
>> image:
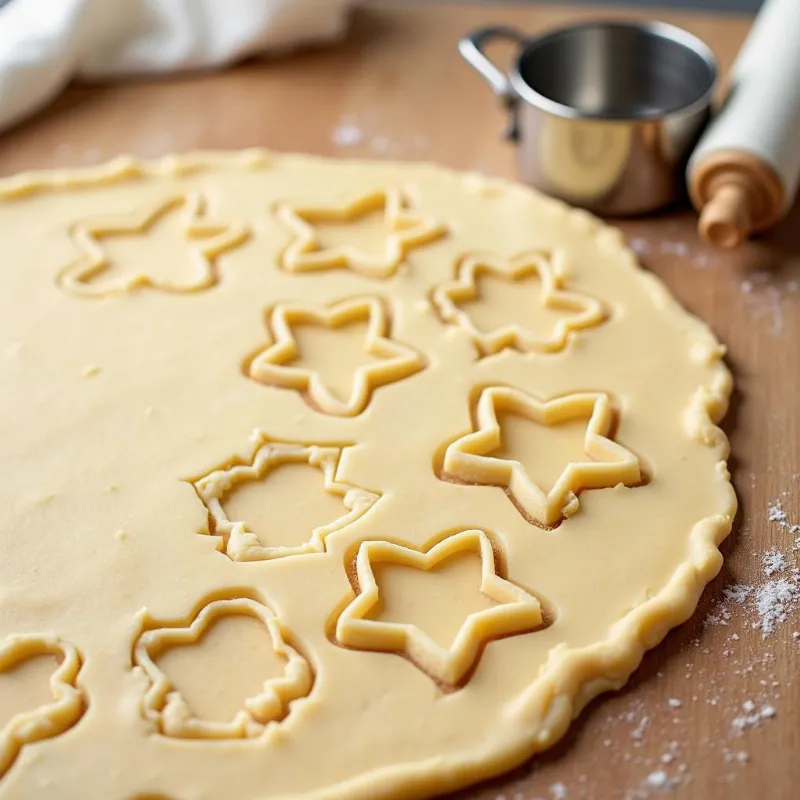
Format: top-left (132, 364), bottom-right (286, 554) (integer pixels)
top-left (336, 530), bottom-right (544, 688)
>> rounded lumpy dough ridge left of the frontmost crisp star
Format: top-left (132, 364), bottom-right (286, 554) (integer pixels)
top-left (133, 598), bottom-right (314, 739)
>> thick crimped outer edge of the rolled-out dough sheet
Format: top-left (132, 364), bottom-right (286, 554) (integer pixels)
top-left (0, 148), bottom-right (737, 800)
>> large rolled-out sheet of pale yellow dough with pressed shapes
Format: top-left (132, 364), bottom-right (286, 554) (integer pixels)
top-left (0, 151), bottom-right (736, 800)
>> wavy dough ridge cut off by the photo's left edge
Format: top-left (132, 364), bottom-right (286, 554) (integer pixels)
top-left (0, 634), bottom-right (86, 777)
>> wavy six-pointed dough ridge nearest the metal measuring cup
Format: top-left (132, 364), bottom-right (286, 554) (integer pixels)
top-left (431, 251), bottom-right (606, 356)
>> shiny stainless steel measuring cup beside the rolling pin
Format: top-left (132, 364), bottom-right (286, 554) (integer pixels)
top-left (459, 22), bottom-right (717, 215)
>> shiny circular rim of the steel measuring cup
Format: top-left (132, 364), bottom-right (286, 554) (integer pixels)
top-left (508, 19), bottom-right (719, 123)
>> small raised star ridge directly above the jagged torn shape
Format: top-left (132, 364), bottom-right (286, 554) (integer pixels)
top-left (245, 297), bottom-right (425, 417)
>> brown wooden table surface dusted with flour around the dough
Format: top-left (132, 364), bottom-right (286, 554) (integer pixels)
top-left (0, 4), bottom-right (800, 800)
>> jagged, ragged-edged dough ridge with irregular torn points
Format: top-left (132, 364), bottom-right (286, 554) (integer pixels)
top-left (193, 432), bottom-right (380, 561)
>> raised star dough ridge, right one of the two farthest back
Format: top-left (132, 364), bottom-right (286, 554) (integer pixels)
top-left (277, 189), bottom-right (446, 278)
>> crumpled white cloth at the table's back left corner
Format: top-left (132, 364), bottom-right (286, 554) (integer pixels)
top-left (0, 0), bottom-right (350, 129)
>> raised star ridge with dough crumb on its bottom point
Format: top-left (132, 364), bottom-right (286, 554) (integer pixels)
top-left (443, 386), bottom-right (642, 527)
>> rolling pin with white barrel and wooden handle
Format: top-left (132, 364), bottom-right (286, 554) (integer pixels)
top-left (686, 0), bottom-right (800, 247)
